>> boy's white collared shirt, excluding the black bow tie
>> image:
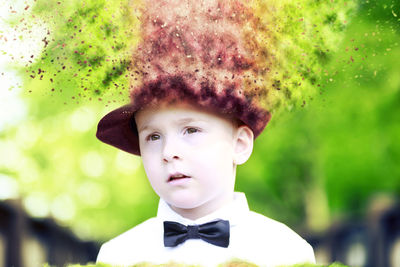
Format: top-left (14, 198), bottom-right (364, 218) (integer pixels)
top-left (97, 193), bottom-right (315, 267)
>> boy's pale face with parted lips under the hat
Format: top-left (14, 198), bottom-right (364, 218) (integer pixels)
top-left (135, 104), bottom-right (237, 219)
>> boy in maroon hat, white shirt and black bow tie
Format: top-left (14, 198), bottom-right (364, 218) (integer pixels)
top-left (97, 0), bottom-right (315, 266)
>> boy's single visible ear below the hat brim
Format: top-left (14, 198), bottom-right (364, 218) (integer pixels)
top-left (233, 125), bottom-right (254, 165)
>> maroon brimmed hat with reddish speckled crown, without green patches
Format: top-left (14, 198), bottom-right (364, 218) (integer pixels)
top-left (96, 0), bottom-right (271, 155)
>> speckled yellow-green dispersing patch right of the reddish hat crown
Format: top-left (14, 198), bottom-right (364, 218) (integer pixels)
top-left (253, 0), bottom-right (356, 113)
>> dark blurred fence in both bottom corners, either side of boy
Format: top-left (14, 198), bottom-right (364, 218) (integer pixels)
top-left (0, 199), bottom-right (400, 267)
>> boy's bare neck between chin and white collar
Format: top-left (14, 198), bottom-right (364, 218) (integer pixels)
top-left (170, 192), bottom-right (233, 221)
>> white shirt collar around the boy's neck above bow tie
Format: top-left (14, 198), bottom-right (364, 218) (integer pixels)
top-left (157, 192), bottom-right (249, 226)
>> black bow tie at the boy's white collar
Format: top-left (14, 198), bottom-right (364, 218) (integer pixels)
top-left (164, 220), bottom-right (230, 248)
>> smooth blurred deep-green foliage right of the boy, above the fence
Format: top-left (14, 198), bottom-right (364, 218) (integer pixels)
top-left (237, 1), bottom-right (400, 230)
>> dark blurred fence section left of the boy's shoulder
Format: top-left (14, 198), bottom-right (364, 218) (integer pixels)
top-left (0, 201), bottom-right (99, 267)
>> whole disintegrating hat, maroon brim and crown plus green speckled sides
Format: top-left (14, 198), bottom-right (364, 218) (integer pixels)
top-left (15, 0), bottom-right (355, 155)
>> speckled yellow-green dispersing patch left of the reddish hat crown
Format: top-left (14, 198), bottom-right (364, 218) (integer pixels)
top-left (20, 0), bottom-right (138, 102)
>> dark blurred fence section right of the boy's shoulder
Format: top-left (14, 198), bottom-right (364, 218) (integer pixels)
top-left (305, 201), bottom-right (400, 267)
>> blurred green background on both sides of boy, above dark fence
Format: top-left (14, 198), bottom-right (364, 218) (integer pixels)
top-left (0, 0), bottom-right (400, 245)
